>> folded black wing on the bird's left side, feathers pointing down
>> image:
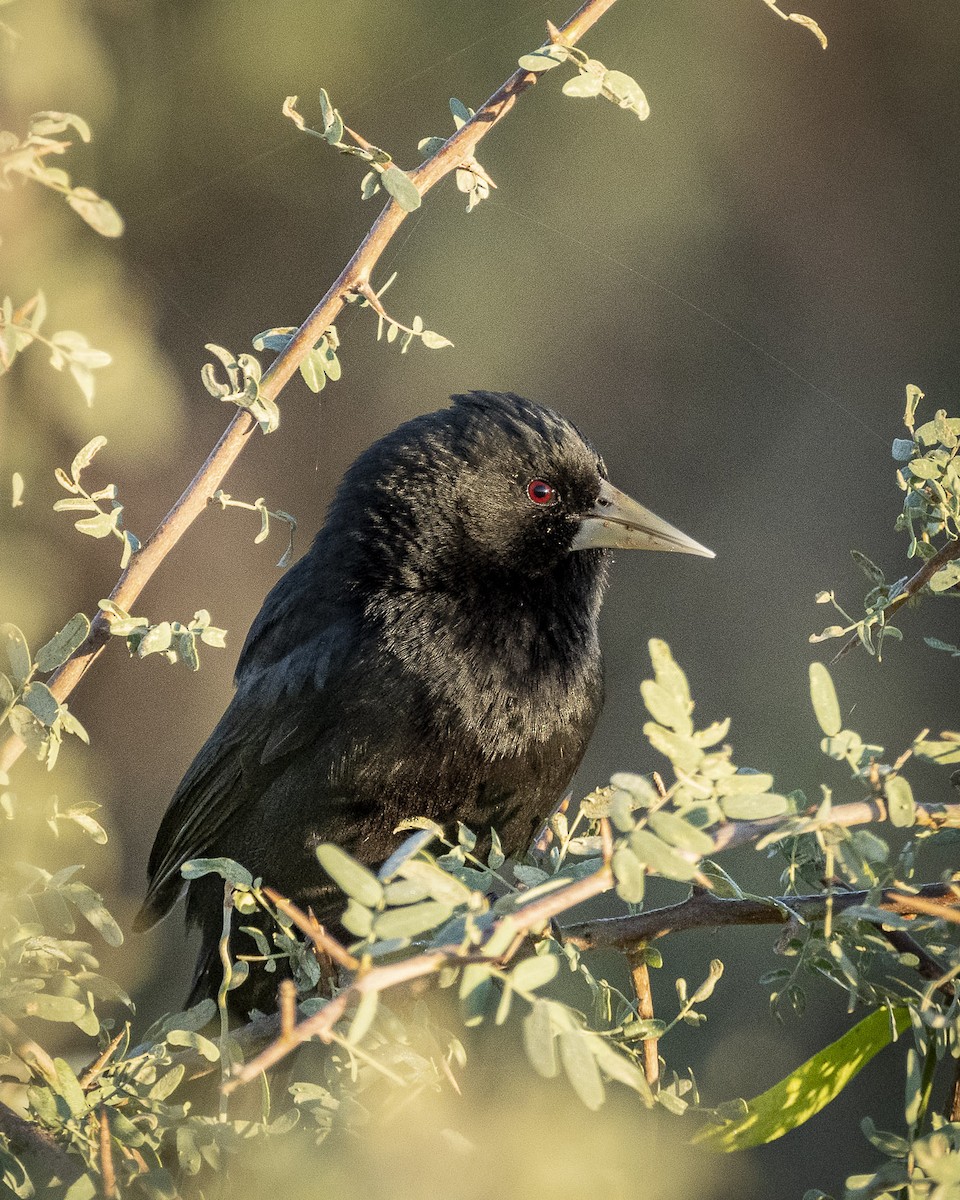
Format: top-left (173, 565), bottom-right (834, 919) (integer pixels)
top-left (133, 625), bottom-right (344, 930)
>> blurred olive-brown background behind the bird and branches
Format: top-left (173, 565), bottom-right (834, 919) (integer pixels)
top-left (0, 0), bottom-right (960, 1198)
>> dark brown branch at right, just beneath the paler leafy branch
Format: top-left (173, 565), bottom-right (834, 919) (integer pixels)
top-left (563, 883), bottom-right (960, 950)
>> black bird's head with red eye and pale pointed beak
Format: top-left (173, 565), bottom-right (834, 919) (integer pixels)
top-left (331, 391), bottom-right (713, 600)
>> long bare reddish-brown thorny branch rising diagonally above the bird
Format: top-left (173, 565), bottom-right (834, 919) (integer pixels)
top-left (0, 0), bottom-right (616, 770)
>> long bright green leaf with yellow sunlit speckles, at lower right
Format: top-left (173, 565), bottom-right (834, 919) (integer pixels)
top-left (694, 1008), bottom-right (910, 1153)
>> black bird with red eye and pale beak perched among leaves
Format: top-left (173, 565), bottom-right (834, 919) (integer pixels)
top-left (134, 391), bottom-right (713, 1008)
